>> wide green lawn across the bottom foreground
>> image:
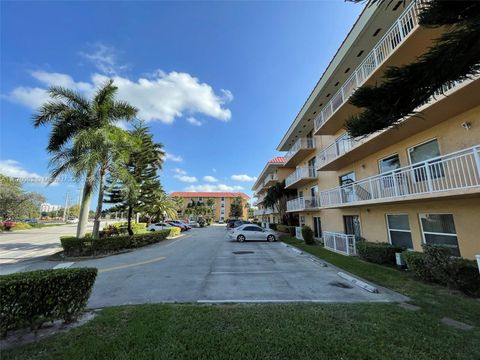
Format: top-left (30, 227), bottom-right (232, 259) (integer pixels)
top-left (2, 304), bottom-right (480, 360)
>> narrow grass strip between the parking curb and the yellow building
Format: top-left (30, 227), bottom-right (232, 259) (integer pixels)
top-left (282, 236), bottom-right (480, 327)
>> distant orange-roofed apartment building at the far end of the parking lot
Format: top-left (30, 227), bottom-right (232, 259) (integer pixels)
top-left (170, 191), bottom-right (250, 222)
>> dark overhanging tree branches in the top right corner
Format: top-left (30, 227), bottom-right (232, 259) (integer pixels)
top-left (345, 0), bottom-right (480, 137)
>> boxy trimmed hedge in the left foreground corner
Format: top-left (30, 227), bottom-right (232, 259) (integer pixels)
top-left (0, 268), bottom-right (97, 336)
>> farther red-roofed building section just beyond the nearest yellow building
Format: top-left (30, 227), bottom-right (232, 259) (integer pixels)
top-left (252, 156), bottom-right (292, 224)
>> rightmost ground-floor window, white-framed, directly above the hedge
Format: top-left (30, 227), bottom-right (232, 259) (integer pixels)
top-left (420, 214), bottom-right (460, 256)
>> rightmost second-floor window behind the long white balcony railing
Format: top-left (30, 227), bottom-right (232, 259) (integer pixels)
top-left (408, 139), bottom-right (445, 182)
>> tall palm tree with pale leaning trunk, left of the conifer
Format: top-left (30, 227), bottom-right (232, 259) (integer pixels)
top-left (33, 80), bottom-right (138, 237)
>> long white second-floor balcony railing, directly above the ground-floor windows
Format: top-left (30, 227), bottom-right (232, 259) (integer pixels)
top-left (320, 145), bottom-right (480, 207)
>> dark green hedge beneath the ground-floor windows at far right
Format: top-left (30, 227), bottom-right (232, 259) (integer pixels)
top-left (404, 245), bottom-right (480, 297)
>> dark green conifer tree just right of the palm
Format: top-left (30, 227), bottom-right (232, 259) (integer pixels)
top-left (105, 123), bottom-right (165, 235)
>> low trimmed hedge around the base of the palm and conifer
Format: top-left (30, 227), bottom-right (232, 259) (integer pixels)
top-left (60, 229), bottom-right (171, 256)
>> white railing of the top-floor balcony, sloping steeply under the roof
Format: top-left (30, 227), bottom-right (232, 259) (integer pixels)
top-left (315, 0), bottom-right (428, 131)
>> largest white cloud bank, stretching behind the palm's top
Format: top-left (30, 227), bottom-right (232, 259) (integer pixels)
top-left (6, 71), bottom-right (233, 124)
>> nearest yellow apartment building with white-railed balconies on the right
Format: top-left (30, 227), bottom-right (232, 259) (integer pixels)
top-left (266, 0), bottom-right (480, 258)
